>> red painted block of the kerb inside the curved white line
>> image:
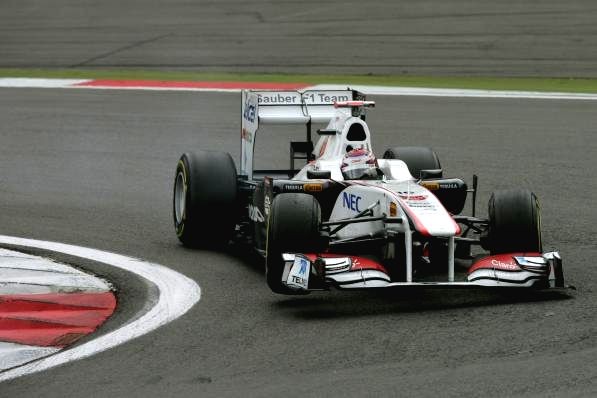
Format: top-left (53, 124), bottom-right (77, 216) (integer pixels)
top-left (0, 292), bottom-right (116, 347)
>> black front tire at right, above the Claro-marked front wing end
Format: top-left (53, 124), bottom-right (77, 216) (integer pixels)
top-left (487, 189), bottom-right (542, 254)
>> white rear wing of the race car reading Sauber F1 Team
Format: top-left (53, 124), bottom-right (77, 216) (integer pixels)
top-left (239, 89), bottom-right (365, 180)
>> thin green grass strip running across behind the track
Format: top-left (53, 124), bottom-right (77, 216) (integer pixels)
top-left (0, 68), bottom-right (597, 93)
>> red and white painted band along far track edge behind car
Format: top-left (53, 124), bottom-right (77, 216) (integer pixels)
top-left (0, 77), bottom-right (597, 101)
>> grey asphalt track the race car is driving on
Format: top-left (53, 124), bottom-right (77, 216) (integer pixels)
top-left (0, 89), bottom-right (597, 397)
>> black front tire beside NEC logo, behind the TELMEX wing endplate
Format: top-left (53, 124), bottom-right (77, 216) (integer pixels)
top-left (265, 193), bottom-right (321, 294)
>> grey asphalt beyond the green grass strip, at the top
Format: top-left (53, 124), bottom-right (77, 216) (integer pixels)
top-left (0, 0), bottom-right (597, 77)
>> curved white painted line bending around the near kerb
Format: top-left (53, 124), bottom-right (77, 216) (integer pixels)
top-left (0, 235), bottom-right (201, 381)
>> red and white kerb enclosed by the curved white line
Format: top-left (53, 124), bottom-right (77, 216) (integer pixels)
top-left (0, 249), bottom-right (116, 372)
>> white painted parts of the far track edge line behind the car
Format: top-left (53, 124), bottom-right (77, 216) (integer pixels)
top-left (0, 77), bottom-right (597, 101)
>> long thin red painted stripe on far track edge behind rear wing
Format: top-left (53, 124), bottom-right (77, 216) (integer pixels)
top-left (74, 79), bottom-right (309, 90)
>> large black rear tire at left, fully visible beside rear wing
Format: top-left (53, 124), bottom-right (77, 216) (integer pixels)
top-left (172, 151), bottom-right (238, 249)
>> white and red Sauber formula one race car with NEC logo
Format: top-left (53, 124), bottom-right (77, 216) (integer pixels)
top-left (173, 89), bottom-right (564, 294)
